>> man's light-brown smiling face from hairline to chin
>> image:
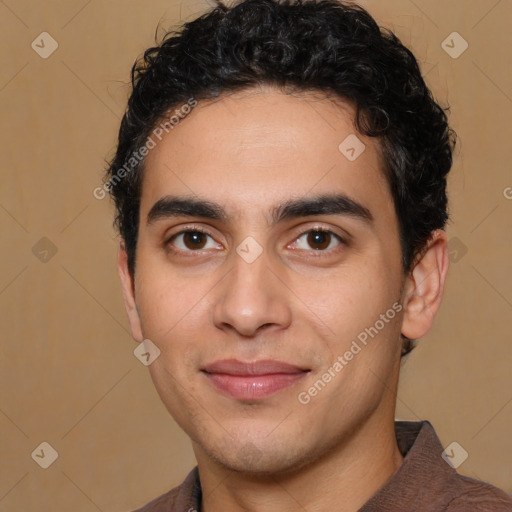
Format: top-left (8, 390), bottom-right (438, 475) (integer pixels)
top-left (121, 88), bottom-right (412, 472)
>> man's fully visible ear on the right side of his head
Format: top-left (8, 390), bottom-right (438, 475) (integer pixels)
top-left (402, 229), bottom-right (450, 340)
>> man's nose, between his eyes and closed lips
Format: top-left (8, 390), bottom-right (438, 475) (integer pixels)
top-left (213, 247), bottom-right (292, 337)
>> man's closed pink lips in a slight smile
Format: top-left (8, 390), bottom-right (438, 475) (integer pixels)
top-left (201, 359), bottom-right (310, 400)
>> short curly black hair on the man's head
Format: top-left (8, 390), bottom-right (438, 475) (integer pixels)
top-left (104, 0), bottom-right (456, 352)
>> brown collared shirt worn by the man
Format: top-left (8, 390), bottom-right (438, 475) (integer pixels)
top-left (135, 421), bottom-right (512, 512)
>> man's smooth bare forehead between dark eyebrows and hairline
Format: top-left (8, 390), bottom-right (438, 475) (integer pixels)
top-left (141, 87), bottom-right (393, 224)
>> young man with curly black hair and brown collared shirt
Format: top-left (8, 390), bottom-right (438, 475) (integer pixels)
top-left (105, 0), bottom-right (512, 512)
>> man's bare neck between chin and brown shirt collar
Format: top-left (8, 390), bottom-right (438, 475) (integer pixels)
top-left (194, 409), bottom-right (402, 512)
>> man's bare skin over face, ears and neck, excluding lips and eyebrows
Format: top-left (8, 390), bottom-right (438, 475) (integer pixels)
top-left (118, 87), bottom-right (448, 512)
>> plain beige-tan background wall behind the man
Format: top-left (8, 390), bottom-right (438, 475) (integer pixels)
top-left (0, 0), bottom-right (512, 512)
